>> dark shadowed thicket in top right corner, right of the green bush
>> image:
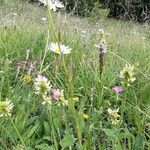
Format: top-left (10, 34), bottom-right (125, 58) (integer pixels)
top-left (107, 0), bottom-right (150, 22)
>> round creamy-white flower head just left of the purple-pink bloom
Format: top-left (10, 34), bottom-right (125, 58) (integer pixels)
top-left (34, 75), bottom-right (51, 95)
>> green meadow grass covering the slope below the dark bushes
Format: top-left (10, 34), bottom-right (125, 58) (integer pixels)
top-left (0, 0), bottom-right (150, 150)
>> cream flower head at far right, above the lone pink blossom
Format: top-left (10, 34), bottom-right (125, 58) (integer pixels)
top-left (120, 64), bottom-right (136, 86)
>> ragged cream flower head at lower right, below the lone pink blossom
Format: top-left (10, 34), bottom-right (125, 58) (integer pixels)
top-left (107, 108), bottom-right (120, 125)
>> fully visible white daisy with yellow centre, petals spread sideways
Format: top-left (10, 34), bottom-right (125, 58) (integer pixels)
top-left (48, 43), bottom-right (72, 55)
